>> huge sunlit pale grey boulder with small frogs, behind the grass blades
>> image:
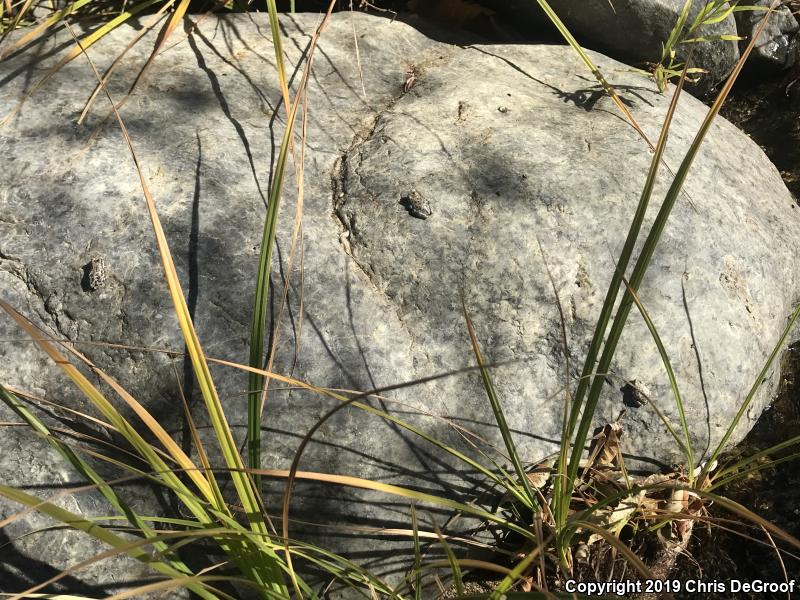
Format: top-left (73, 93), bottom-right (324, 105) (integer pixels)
top-left (0, 11), bottom-right (800, 587)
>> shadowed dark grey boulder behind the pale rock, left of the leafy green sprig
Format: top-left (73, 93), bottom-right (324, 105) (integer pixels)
top-left (482, 0), bottom-right (739, 95)
